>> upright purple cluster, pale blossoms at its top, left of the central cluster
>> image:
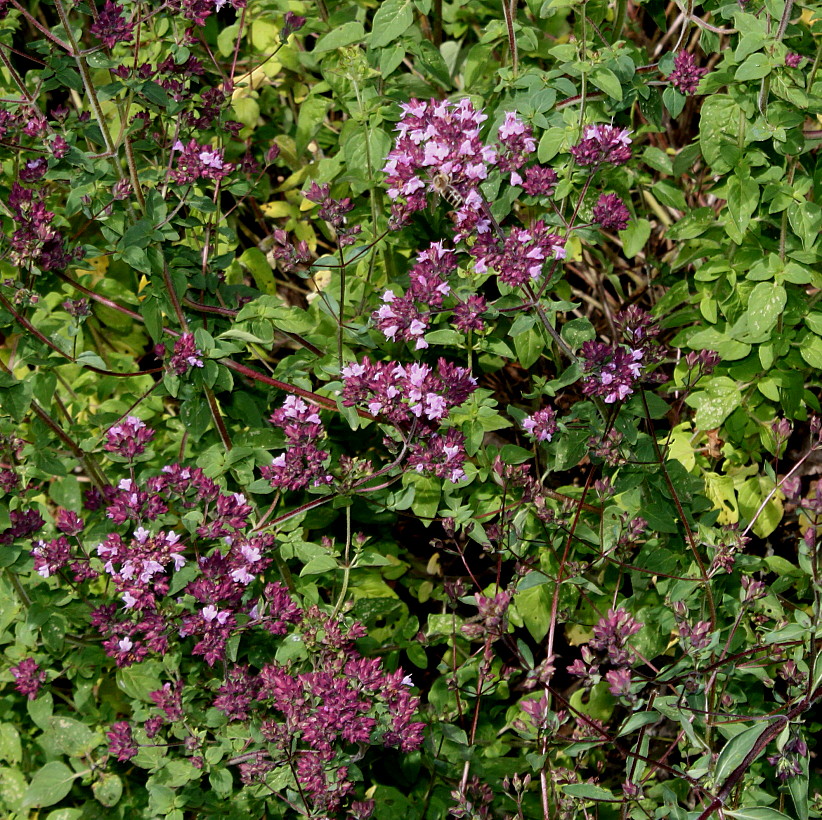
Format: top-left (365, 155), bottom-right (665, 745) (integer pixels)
top-left (261, 396), bottom-right (332, 490)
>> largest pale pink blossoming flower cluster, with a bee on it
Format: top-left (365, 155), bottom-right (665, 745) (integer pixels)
top-left (383, 99), bottom-right (497, 231)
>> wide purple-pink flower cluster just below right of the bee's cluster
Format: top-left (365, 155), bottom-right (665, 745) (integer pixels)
top-left (470, 220), bottom-right (565, 287)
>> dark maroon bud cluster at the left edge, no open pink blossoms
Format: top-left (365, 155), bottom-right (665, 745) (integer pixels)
top-left (8, 182), bottom-right (74, 271)
